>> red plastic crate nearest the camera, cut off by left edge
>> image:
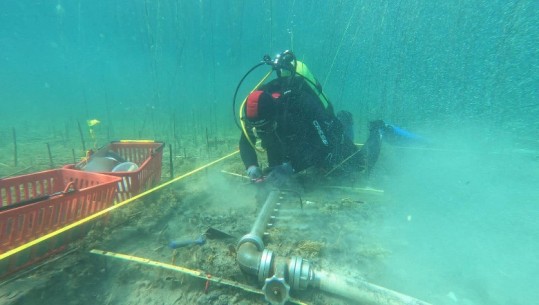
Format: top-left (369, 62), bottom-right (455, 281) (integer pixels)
top-left (0, 169), bottom-right (121, 253)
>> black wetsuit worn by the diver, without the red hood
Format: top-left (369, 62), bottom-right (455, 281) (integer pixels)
top-left (240, 76), bottom-right (380, 172)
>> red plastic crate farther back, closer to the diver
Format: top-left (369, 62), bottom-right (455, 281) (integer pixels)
top-left (65, 140), bottom-right (165, 202)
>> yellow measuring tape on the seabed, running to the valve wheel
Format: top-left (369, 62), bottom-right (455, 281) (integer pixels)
top-left (90, 249), bottom-right (307, 305)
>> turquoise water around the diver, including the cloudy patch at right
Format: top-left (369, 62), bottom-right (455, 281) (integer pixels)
top-left (0, 0), bottom-right (539, 304)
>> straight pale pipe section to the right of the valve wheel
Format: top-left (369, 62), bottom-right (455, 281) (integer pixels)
top-left (315, 271), bottom-right (430, 305)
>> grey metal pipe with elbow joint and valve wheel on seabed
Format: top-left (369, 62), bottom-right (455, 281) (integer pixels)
top-left (236, 191), bottom-right (430, 305)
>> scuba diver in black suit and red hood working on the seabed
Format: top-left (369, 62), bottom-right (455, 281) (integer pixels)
top-left (234, 51), bottom-right (391, 187)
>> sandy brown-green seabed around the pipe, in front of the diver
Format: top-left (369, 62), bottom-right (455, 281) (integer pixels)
top-left (0, 134), bottom-right (388, 304)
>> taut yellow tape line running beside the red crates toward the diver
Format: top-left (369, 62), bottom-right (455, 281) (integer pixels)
top-left (0, 150), bottom-right (239, 260)
